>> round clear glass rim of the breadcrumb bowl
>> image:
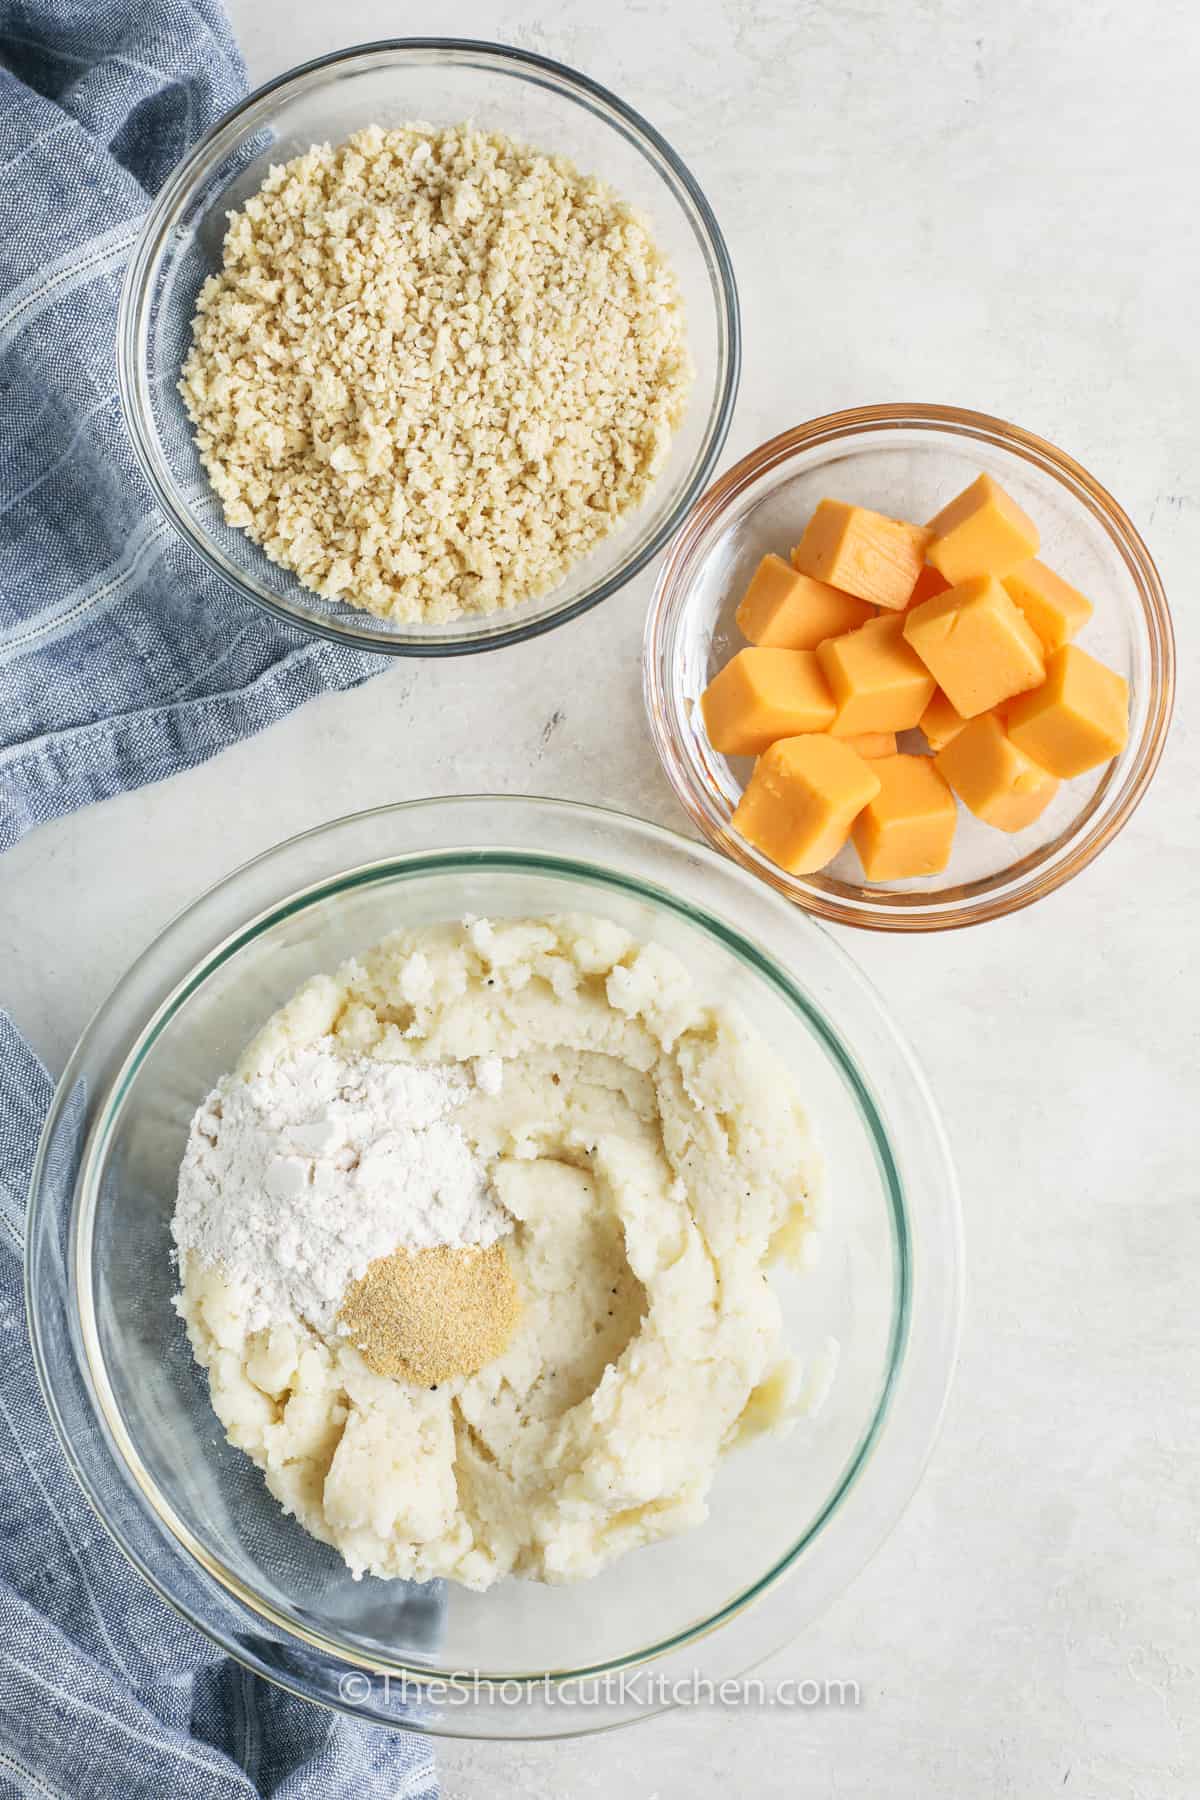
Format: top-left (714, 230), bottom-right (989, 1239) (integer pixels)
top-left (117, 36), bottom-right (741, 657)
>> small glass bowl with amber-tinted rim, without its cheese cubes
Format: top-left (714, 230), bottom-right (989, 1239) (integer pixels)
top-left (642, 405), bottom-right (1175, 931)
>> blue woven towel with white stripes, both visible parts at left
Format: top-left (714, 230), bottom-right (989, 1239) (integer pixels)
top-left (0, 0), bottom-right (437, 1800)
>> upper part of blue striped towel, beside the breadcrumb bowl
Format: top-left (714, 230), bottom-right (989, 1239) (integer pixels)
top-left (0, 0), bottom-right (383, 850)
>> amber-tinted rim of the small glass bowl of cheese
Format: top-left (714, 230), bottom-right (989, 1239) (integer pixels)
top-left (642, 401), bottom-right (1175, 931)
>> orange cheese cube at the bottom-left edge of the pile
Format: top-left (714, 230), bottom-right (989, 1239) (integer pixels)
top-left (734, 733), bottom-right (880, 875)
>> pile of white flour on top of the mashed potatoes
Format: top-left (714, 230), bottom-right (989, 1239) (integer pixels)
top-left (173, 1040), bottom-right (511, 1332)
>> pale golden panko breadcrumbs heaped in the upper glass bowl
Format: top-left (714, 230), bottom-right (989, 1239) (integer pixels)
top-left (180, 124), bottom-right (691, 621)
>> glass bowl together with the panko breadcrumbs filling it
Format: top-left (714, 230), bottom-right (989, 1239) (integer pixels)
top-left (119, 40), bottom-right (739, 655)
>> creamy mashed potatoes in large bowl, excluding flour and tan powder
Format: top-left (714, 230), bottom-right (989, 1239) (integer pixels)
top-left (180, 916), bottom-right (817, 1588)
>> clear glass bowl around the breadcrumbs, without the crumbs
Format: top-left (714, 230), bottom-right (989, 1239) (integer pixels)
top-left (117, 38), bottom-right (741, 655)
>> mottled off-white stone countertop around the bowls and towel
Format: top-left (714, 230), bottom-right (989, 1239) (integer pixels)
top-left (0, 0), bottom-right (1200, 1800)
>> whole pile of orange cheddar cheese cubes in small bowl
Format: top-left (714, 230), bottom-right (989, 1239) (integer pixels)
top-left (700, 475), bottom-right (1130, 882)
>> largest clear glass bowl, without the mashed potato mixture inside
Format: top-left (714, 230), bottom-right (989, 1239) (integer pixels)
top-left (27, 797), bottom-right (961, 1737)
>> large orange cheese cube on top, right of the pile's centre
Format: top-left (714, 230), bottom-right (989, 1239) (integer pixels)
top-left (905, 574), bottom-right (1045, 718)
